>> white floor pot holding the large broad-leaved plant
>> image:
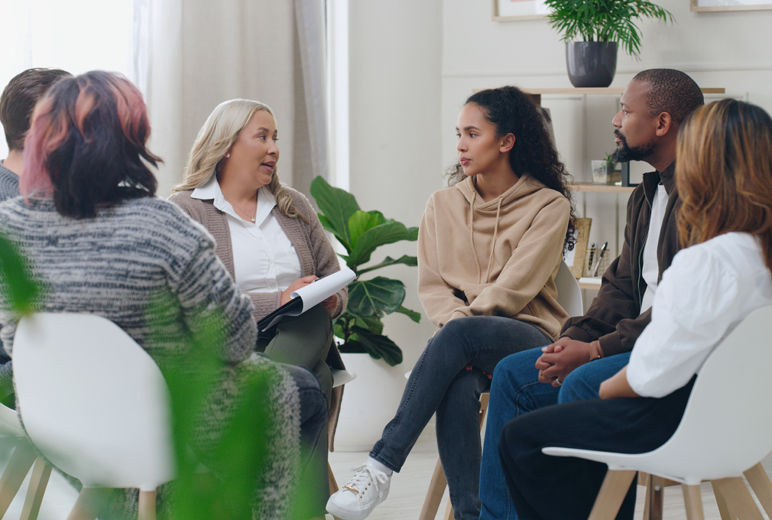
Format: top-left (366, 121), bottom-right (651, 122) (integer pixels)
top-left (335, 354), bottom-right (410, 452)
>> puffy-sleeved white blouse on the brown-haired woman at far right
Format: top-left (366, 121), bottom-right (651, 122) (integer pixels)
top-left (627, 233), bottom-right (772, 397)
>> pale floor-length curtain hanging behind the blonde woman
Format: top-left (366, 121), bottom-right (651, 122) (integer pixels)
top-left (142, 0), bottom-right (328, 196)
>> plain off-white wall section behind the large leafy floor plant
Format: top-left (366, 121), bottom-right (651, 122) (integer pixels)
top-left (349, 0), bottom-right (444, 371)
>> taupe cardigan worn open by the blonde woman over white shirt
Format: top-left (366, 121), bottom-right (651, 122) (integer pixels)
top-left (169, 187), bottom-right (348, 451)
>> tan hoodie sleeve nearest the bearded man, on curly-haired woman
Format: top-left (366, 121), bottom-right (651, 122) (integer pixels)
top-left (450, 197), bottom-right (571, 319)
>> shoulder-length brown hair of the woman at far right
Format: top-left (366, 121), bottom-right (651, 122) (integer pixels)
top-left (676, 99), bottom-right (772, 271)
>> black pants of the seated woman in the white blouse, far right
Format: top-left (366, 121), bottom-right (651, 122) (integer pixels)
top-left (499, 379), bottom-right (694, 520)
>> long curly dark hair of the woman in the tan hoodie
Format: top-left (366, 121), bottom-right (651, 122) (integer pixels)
top-left (447, 86), bottom-right (576, 251)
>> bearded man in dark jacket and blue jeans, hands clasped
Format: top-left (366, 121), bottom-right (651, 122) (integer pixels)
top-left (480, 69), bottom-right (704, 520)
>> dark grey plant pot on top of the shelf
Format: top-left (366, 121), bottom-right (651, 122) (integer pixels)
top-left (566, 42), bottom-right (617, 88)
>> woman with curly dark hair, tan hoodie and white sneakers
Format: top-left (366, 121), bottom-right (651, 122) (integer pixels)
top-left (327, 87), bottom-right (572, 520)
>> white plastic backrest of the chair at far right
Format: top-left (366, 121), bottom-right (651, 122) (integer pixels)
top-left (624, 306), bottom-right (772, 480)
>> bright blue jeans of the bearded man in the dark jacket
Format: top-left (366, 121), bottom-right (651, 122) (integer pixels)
top-left (480, 348), bottom-right (630, 520)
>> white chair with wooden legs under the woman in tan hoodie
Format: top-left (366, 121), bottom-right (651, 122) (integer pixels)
top-left (420, 261), bottom-right (584, 520)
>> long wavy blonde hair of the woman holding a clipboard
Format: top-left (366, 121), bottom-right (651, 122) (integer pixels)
top-left (172, 99), bottom-right (308, 222)
